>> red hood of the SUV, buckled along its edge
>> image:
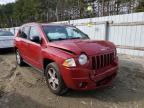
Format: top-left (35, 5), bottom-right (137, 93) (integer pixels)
top-left (48, 39), bottom-right (115, 55)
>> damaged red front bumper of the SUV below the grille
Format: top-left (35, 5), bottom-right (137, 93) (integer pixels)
top-left (59, 66), bottom-right (118, 90)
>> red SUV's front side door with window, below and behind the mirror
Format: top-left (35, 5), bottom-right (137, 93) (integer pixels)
top-left (27, 26), bottom-right (42, 69)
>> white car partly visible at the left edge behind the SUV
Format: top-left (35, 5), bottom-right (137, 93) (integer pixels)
top-left (0, 31), bottom-right (14, 49)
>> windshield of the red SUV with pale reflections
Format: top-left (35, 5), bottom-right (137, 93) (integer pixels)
top-left (43, 25), bottom-right (89, 41)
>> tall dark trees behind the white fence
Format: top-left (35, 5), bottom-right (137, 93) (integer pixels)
top-left (0, 0), bottom-right (144, 28)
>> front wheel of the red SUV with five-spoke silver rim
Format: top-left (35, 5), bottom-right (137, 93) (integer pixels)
top-left (45, 62), bottom-right (68, 95)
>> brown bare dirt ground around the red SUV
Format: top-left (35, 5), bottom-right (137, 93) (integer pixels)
top-left (0, 51), bottom-right (144, 108)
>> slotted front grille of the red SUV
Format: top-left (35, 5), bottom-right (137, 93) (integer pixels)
top-left (92, 52), bottom-right (114, 70)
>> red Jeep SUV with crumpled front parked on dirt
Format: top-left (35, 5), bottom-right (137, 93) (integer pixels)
top-left (15, 23), bottom-right (118, 95)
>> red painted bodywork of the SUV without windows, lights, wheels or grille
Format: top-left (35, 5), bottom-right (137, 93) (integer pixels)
top-left (15, 23), bottom-right (118, 90)
